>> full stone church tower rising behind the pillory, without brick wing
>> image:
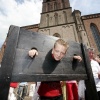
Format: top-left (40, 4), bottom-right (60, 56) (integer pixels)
top-left (39, 0), bottom-right (89, 46)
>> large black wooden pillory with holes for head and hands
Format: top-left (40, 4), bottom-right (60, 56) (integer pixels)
top-left (0, 26), bottom-right (98, 100)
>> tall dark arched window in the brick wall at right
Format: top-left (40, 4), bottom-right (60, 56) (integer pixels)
top-left (90, 23), bottom-right (100, 51)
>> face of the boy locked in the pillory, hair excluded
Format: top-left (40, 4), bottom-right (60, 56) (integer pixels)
top-left (52, 44), bottom-right (66, 61)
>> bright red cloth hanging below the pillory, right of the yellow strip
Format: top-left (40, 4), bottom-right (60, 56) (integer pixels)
top-left (66, 83), bottom-right (78, 100)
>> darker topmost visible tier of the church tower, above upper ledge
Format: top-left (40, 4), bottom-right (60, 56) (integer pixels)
top-left (42, 0), bottom-right (70, 13)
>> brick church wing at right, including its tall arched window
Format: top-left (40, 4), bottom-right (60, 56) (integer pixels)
top-left (81, 13), bottom-right (100, 52)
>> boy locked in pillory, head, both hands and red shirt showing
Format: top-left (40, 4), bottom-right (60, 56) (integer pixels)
top-left (28, 39), bottom-right (82, 100)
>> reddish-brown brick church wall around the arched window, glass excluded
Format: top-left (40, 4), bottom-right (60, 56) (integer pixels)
top-left (82, 14), bottom-right (100, 52)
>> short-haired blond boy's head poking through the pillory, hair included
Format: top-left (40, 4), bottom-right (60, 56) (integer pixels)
top-left (52, 39), bottom-right (68, 61)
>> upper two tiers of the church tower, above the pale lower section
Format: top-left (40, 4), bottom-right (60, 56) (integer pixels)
top-left (40, 0), bottom-right (72, 28)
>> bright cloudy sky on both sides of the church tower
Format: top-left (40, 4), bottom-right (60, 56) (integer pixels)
top-left (0, 0), bottom-right (100, 47)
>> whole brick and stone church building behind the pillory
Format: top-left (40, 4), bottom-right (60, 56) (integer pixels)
top-left (22, 0), bottom-right (100, 53)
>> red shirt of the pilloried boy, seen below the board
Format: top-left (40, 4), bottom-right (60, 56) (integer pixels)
top-left (38, 81), bottom-right (62, 97)
